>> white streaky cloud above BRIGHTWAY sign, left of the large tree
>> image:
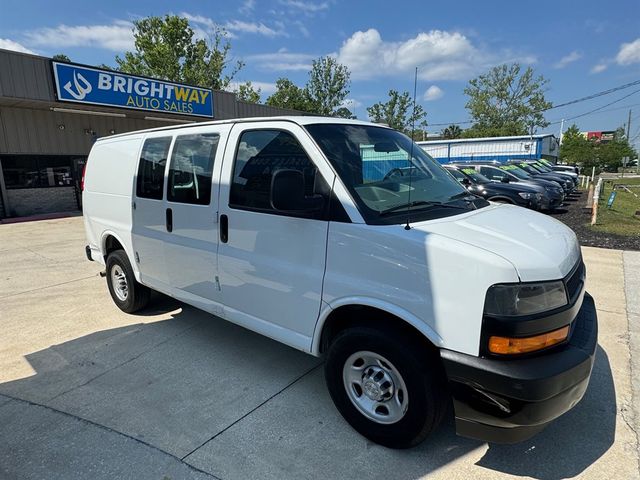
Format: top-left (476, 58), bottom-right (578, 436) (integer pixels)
top-left (25, 20), bottom-right (134, 52)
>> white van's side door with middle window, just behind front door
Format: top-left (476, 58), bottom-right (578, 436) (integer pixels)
top-left (165, 125), bottom-right (231, 315)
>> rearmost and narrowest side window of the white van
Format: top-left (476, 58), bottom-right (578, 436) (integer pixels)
top-left (136, 137), bottom-right (171, 200)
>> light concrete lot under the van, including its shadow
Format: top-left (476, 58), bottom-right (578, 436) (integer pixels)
top-left (0, 217), bottom-right (640, 480)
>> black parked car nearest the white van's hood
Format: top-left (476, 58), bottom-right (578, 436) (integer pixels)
top-left (444, 165), bottom-right (549, 210)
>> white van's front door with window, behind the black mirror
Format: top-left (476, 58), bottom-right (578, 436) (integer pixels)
top-left (218, 122), bottom-right (333, 350)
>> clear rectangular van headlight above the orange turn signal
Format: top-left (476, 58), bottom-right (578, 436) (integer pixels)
top-left (484, 281), bottom-right (568, 316)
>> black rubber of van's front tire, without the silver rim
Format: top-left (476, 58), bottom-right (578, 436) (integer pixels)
top-left (324, 327), bottom-right (449, 448)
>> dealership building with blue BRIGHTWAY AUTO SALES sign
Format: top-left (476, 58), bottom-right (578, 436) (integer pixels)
top-left (0, 49), bottom-right (298, 219)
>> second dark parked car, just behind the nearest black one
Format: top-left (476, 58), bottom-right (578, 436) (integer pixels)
top-left (460, 162), bottom-right (565, 210)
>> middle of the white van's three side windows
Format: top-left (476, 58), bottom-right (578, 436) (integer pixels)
top-left (167, 133), bottom-right (220, 205)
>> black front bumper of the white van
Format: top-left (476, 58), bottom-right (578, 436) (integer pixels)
top-left (441, 293), bottom-right (598, 443)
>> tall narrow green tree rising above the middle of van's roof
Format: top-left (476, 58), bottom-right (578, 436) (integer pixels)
top-left (305, 57), bottom-right (351, 116)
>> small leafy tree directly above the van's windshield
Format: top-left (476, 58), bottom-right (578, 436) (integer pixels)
top-left (367, 90), bottom-right (427, 135)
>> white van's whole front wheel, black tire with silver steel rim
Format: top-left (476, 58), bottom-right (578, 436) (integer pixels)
top-left (325, 327), bottom-right (448, 448)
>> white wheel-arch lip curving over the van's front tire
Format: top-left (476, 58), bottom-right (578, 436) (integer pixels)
top-left (311, 296), bottom-right (444, 356)
